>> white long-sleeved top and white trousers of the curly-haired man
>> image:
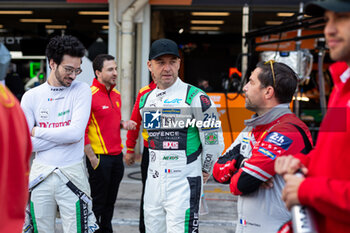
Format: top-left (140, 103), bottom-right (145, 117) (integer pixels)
top-left (21, 81), bottom-right (95, 233)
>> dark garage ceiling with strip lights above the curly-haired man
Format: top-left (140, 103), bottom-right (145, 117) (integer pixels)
top-left (0, 0), bottom-right (109, 51)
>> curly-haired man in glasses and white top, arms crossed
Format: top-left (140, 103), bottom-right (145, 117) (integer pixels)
top-left (21, 36), bottom-right (98, 233)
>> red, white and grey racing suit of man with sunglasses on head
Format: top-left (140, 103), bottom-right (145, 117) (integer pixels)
top-left (213, 105), bottom-right (312, 233)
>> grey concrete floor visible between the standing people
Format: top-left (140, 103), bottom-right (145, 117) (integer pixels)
top-left (56, 163), bottom-right (237, 233)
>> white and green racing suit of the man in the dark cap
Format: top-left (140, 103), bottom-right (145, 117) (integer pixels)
top-left (139, 78), bottom-right (224, 233)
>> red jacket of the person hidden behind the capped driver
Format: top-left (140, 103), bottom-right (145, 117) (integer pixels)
top-left (126, 81), bottom-right (157, 153)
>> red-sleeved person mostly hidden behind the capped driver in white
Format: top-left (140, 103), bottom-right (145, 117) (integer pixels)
top-left (125, 77), bottom-right (157, 233)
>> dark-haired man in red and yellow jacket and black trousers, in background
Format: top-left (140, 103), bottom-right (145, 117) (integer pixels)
top-left (84, 54), bottom-right (136, 233)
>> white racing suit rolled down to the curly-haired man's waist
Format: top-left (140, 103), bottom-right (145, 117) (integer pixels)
top-left (23, 161), bottom-right (98, 233)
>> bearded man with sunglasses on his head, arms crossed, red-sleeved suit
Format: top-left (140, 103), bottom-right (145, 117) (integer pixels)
top-left (213, 61), bottom-right (312, 233)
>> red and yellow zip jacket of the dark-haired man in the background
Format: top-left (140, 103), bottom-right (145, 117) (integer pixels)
top-left (85, 78), bottom-right (123, 155)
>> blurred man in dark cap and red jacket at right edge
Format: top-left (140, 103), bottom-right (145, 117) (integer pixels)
top-left (275, 0), bottom-right (350, 233)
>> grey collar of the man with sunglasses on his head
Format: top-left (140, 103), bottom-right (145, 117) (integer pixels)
top-left (244, 104), bottom-right (292, 127)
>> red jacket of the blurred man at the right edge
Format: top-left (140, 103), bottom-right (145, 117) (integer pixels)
top-left (296, 62), bottom-right (350, 233)
